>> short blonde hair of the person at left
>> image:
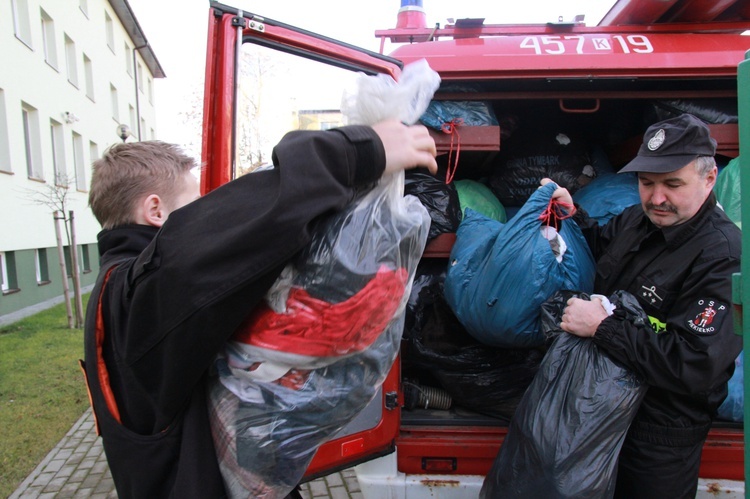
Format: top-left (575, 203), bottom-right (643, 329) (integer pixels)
top-left (89, 140), bottom-right (196, 229)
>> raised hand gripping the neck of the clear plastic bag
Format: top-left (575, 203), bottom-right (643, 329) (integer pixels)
top-left (372, 120), bottom-right (437, 174)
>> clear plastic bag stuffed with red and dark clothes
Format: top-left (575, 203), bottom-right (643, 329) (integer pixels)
top-left (209, 59), bottom-right (438, 498)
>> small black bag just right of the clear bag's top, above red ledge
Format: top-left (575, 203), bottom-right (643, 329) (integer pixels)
top-left (404, 171), bottom-right (461, 241)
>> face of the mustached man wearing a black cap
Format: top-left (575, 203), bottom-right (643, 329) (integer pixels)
top-left (638, 162), bottom-right (716, 227)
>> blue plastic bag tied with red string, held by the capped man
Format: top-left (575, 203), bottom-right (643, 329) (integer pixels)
top-left (445, 183), bottom-right (595, 348)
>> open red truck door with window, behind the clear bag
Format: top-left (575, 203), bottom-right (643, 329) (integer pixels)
top-left (201, 2), bottom-right (402, 479)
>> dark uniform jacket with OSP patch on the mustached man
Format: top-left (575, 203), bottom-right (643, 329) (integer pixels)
top-left (584, 194), bottom-right (742, 445)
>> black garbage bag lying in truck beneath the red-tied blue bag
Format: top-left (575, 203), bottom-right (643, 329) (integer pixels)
top-left (402, 261), bottom-right (544, 420)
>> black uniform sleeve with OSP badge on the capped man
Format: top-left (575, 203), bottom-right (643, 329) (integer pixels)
top-left (594, 252), bottom-right (742, 394)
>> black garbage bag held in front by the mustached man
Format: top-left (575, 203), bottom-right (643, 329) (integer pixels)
top-left (480, 291), bottom-right (648, 499)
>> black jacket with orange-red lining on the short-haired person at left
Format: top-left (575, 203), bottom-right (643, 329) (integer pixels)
top-left (85, 126), bottom-right (385, 499)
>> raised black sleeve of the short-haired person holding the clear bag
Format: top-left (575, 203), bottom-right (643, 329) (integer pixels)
top-left (118, 126), bottom-right (385, 430)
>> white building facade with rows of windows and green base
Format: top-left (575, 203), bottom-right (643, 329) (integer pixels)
top-left (0, 0), bottom-right (165, 325)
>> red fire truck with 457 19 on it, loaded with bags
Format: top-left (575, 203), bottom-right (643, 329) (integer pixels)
top-left (202, 0), bottom-right (750, 498)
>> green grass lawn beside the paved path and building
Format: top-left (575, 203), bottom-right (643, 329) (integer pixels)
top-left (0, 295), bottom-right (89, 497)
